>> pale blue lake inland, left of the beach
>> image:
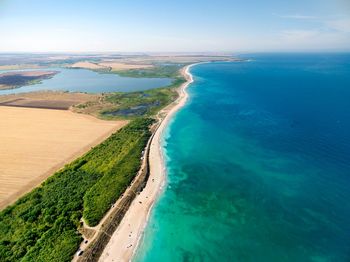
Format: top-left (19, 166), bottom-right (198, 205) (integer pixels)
top-left (0, 68), bottom-right (172, 95)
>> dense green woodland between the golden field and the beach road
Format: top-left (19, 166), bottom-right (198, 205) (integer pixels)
top-left (0, 118), bottom-right (153, 261)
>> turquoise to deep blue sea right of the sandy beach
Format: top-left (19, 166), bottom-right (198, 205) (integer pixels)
top-left (134, 54), bottom-right (350, 262)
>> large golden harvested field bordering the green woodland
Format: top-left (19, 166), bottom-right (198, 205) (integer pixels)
top-left (0, 106), bottom-right (127, 209)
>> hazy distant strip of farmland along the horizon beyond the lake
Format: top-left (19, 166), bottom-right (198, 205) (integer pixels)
top-left (0, 53), bottom-right (239, 71)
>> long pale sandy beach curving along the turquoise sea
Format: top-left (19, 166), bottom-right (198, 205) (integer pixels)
top-left (99, 63), bottom-right (198, 262)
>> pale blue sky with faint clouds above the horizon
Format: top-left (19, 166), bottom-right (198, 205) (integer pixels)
top-left (0, 0), bottom-right (350, 53)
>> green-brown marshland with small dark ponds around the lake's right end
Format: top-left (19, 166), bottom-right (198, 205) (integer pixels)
top-left (75, 65), bottom-right (186, 119)
